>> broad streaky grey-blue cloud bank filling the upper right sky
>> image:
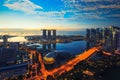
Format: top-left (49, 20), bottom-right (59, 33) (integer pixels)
top-left (62, 0), bottom-right (120, 19)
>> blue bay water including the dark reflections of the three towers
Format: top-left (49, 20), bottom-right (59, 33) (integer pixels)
top-left (39, 41), bottom-right (86, 56)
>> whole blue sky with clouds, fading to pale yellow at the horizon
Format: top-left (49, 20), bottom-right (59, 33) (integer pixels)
top-left (0, 0), bottom-right (120, 30)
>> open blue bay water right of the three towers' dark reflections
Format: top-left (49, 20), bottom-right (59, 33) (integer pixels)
top-left (56, 41), bottom-right (86, 56)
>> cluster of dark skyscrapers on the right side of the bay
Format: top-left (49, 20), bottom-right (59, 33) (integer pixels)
top-left (86, 26), bottom-right (120, 51)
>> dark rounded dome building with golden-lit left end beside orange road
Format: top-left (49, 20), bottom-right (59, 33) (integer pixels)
top-left (43, 51), bottom-right (72, 64)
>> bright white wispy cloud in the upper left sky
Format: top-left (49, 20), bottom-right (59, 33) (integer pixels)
top-left (4, 0), bottom-right (42, 14)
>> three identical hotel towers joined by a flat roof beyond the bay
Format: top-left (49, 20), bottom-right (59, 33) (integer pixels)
top-left (42, 29), bottom-right (56, 40)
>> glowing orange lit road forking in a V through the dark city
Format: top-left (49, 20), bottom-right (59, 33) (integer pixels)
top-left (24, 46), bottom-right (102, 80)
